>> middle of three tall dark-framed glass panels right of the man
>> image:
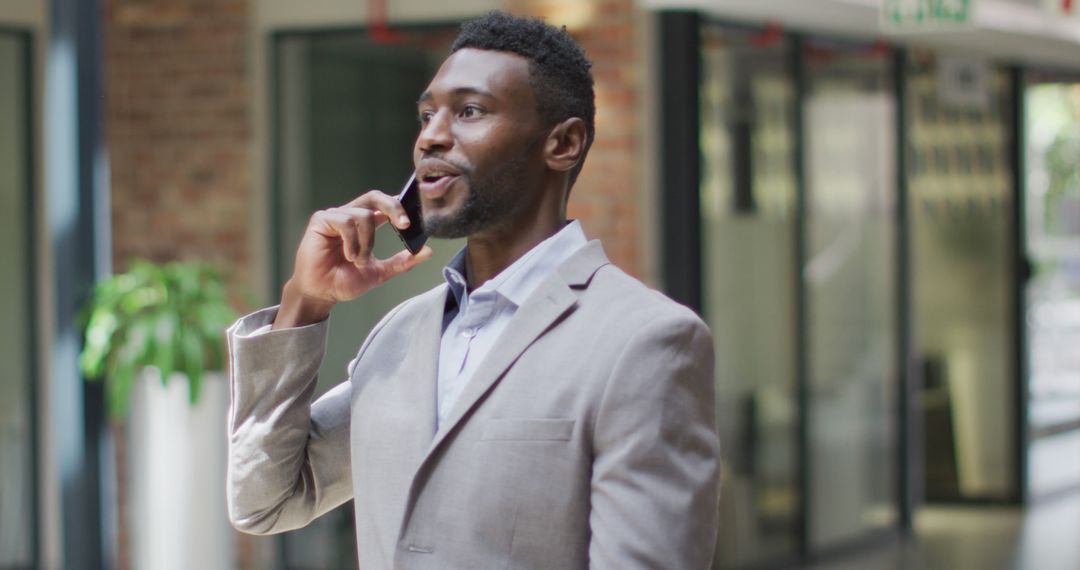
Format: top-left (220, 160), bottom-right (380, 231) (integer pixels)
top-left (802, 37), bottom-right (899, 548)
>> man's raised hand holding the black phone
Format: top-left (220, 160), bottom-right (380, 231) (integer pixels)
top-left (273, 190), bottom-right (432, 328)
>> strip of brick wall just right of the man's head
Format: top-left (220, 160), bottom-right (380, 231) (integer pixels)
top-left (505, 0), bottom-right (643, 275)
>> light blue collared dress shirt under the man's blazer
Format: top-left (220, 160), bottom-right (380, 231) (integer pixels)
top-left (435, 220), bottom-right (588, 430)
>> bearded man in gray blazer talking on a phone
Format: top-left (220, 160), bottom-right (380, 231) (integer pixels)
top-left (228, 13), bottom-right (718, 570)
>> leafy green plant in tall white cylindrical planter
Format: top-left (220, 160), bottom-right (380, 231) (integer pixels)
top-left (80, 261), bottom-right (235, 570)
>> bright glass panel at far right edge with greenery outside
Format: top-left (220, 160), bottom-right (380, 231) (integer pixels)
top-left (1025, 83), bottom-right (1080, 494)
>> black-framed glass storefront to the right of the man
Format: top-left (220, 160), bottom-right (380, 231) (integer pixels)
top-left (650, 1), bottom-right (1080, 568)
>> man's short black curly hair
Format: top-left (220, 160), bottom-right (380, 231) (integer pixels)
top-left (450, 11), bottom-right (596, 186)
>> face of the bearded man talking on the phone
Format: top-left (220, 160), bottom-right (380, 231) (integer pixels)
top-left (413, 49), bottom-right (545, 238)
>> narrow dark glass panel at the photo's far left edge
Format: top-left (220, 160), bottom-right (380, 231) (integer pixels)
top-left (0, 32), bottom-right (36, 568)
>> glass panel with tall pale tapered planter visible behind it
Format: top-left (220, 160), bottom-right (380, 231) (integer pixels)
top-left (904, 52), bottom-right (1016, 500)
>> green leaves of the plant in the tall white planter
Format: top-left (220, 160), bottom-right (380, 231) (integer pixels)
top-left (79, 260), bottom-right (235, 418)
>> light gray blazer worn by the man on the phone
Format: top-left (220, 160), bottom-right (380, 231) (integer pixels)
top-left (228, 242), bottom-right (719, 570)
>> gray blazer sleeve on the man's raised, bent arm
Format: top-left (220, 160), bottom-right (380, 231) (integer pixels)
top-left (226, 308), bottom-right (352, 534)
